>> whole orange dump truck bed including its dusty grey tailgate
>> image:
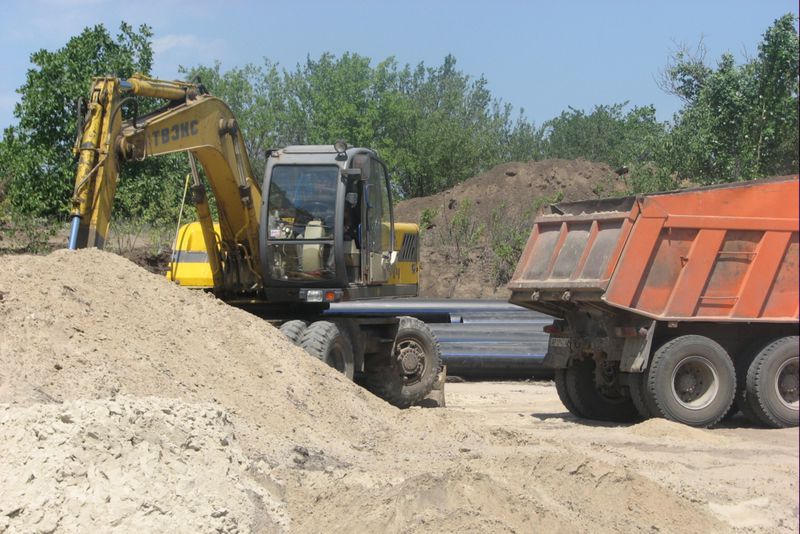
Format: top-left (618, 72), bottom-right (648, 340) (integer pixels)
top-left (508, 176), bottom-right (800, 322)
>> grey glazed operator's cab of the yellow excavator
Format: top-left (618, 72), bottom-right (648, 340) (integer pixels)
top-left (261, 143), bottom-right (418, 302)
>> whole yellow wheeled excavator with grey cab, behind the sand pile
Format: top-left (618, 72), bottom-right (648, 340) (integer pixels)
top-left (69, 75), bottom-right (442, 407)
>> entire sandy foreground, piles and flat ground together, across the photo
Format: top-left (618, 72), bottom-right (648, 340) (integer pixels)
top-left (0, 250), bottom-right (798, 533)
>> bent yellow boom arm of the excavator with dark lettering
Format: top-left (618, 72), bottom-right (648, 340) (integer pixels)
top-left (69, 76), bottom-right (261, 289)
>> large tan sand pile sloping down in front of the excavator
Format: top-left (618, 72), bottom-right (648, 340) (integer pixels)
top-left (0, 250), bottom-right (395, 447)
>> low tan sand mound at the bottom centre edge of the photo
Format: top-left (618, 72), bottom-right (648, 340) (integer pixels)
top-left (294, 446), bottom-right (725, 534)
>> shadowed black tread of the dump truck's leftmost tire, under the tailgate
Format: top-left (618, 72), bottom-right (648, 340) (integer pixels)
top-left (566, 359), bottom-right (639, 423)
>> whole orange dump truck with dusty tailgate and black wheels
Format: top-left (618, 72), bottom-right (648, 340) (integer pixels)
top-left (508, 176), bottom-right (800, 427)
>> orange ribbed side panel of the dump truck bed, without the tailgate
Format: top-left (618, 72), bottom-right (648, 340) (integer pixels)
top-left (603, 180), bottom-right (800, 322)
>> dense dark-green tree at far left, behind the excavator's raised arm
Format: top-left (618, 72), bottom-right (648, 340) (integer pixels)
top-left (0, 22), bottom-right (188, 224)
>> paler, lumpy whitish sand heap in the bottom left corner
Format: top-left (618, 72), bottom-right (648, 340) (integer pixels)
top-left (0, 397), bottom-right (288, 532)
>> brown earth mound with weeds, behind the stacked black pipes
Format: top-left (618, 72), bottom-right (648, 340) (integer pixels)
top-left (394, 160), bottom-right (626, 298)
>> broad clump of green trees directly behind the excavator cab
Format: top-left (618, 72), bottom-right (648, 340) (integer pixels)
top-left (184, 53), bottom-right (538, 197)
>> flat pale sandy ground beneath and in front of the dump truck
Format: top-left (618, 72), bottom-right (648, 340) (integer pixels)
top-left (446, 382), bottom-right (798, 532)
